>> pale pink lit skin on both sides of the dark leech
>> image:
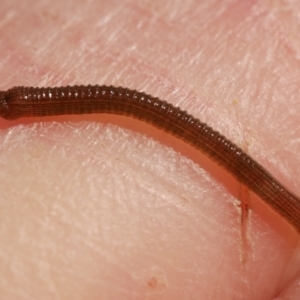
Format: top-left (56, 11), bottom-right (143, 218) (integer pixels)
top-left (0, 1), bottom-right (300, 300)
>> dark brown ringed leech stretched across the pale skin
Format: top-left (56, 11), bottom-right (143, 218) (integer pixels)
top-left (0, 85), bottom-right (300, 233)
